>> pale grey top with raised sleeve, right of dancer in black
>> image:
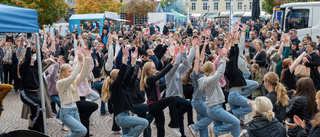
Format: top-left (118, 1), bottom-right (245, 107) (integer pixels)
top-left (238, 37), bottom-right (249, 73)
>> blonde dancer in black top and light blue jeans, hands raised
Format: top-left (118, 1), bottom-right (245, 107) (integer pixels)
top-left (102, 46), bottom-right (149, 137)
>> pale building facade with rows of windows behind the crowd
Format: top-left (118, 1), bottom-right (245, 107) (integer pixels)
top-left (188, 0), bottom-right (263, 14)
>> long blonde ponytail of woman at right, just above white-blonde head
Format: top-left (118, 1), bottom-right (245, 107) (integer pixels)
top-left (264, 72), bottom-right (289, 107)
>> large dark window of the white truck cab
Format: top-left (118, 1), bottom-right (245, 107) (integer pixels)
top-left (286, 9), bottom-right (309, 30)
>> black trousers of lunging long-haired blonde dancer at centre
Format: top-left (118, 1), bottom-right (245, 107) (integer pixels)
top-left (148, 97), bottom-right (179, 137)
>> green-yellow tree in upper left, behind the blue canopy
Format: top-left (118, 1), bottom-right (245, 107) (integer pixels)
top-left (0, 0), bottom-right (69, 26)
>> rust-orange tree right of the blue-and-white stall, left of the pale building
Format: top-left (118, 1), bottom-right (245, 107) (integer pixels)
top-left (124, 0), bottom-right (157, 20)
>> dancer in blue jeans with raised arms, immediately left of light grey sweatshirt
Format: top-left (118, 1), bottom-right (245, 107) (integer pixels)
top-left (188, 41), bottom-right (212, 137)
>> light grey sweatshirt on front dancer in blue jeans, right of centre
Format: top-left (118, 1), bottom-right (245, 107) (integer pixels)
top-left (198, 58), bottom-right (227, 107)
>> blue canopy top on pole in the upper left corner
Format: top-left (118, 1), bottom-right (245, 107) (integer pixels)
top-left (0, 4), bottom-right (39, 33)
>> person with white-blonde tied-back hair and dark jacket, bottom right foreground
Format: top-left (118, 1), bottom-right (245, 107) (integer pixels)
top-left (241, 97), bottom-right (287, 137)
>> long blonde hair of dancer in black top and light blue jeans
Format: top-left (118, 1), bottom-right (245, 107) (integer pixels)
top-left (101, 69), bottom-right (119, 102)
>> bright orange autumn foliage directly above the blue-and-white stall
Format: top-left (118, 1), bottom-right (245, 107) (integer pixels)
top-left (75, 0), bottom-right (122, 14)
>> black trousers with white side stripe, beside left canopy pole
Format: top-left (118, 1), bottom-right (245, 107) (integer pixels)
top-left (20, 90), bottom-right (44, 133)
